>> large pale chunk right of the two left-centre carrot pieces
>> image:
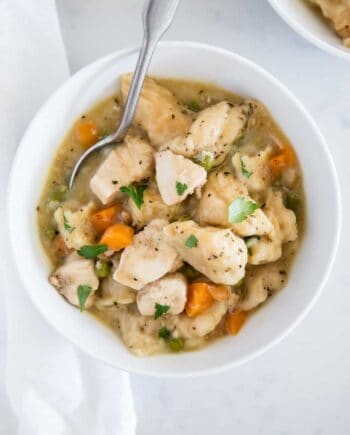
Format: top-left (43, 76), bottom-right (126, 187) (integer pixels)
top-left (113, 219), bottom-right (181, 290)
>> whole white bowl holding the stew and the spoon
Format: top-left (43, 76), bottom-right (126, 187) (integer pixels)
top-left (7, 42), bottom-right (340, 376)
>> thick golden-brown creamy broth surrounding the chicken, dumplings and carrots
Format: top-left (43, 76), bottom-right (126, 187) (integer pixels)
top-left (37, 78), bottom-right (305, 355)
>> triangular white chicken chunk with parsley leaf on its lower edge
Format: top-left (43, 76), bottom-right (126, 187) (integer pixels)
top-left (155, 151), bottom-right (207, 205)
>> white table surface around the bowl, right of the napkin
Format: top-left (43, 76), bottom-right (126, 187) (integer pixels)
top-left (0, 0), bottom-right (350, 435)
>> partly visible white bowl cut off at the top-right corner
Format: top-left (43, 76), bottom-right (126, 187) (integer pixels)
top-left (268, 0), bottom-right (350, 61)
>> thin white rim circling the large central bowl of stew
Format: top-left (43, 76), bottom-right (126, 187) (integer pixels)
top-left (6, 41), bottom-right (342, 378)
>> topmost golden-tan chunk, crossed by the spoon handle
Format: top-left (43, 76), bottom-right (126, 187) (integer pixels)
top-left (121, 74), bottom-right (191, 148)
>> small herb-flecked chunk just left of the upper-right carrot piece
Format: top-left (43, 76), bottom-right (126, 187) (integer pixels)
top-left (232, 147), bottom-right (273, 193)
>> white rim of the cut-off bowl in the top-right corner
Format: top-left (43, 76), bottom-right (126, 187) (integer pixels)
top-left (268, 0), bottom-right (350, 62)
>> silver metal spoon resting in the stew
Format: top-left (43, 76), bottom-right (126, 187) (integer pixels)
top-left (68, 0), bottom-right (180, 189)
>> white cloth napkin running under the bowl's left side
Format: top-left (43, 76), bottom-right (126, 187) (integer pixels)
top-left (0, 0), bottom-right (136, 435)
